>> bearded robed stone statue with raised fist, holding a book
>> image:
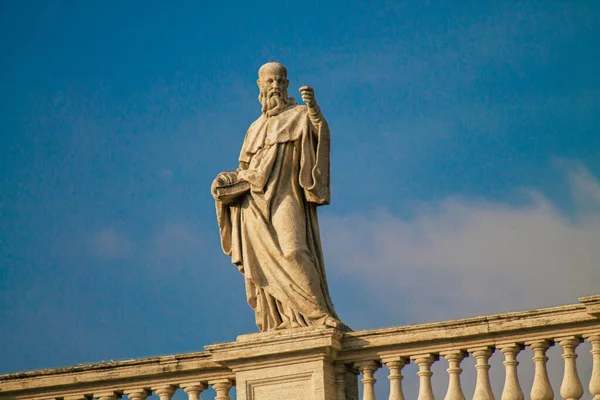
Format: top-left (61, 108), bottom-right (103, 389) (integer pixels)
top-left (212, 62), bottom-right (347, 332)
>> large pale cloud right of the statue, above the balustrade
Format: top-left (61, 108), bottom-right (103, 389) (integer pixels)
top-left (322, 165), bottom-right (600, 323)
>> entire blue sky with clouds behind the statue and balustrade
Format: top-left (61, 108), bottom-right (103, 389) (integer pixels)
top-left (0, 1), bottom-right (600, 390)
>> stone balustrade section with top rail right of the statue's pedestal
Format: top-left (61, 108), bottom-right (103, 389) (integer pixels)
top-left (341, 296), bottom-right (600, 400)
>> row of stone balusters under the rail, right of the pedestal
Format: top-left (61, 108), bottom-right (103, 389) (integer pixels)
top-left (355, 333), bottom-right (600, 400)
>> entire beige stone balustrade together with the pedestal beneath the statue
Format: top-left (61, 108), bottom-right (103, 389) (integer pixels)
top-left (0, 296), bottom-right (600, 400)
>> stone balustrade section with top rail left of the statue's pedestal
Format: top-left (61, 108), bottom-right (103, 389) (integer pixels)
top-left (0, 352), bottom-right (235, 400)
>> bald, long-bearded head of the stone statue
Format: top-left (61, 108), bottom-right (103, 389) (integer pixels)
top-left (256, 62), bottom-right (290, 116)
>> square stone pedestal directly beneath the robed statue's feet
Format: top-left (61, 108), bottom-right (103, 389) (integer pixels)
top-left (206, 327), bottom-right (358, 400)
